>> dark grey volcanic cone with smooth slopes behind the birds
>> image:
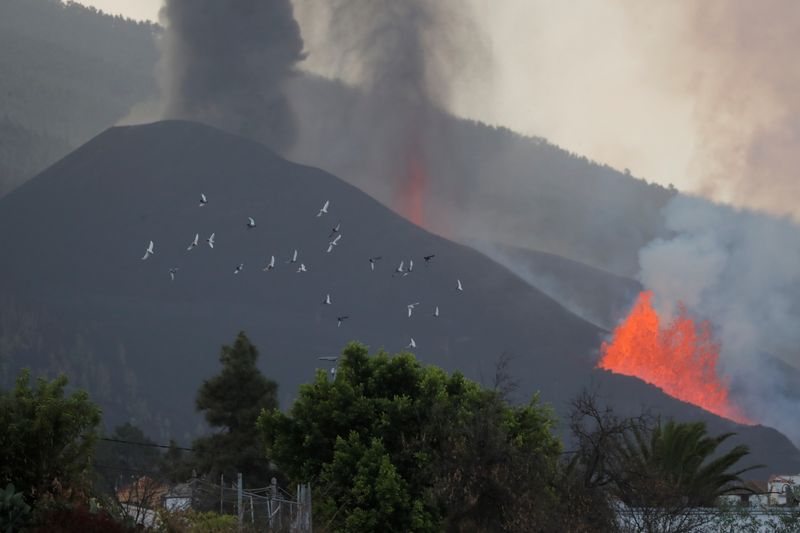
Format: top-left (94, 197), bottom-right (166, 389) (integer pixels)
top-left (0, 121), bottom-right (800, 471)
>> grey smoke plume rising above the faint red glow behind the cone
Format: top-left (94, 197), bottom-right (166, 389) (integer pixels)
top-left (295, 0), bottom-right (483, 226)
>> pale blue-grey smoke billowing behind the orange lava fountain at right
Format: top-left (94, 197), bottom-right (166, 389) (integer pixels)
top-left (639, 196), bottom-right (800, 442)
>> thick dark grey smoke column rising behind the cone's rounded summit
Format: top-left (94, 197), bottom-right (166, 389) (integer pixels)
top-left (158, 0), bottom-right (303, 151)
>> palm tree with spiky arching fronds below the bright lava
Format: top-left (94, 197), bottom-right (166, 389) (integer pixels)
top-left (618, 420), bottom-right (761, 507)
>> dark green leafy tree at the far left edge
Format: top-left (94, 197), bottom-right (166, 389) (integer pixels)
top-left (0, 370), bottom-right (100, 503)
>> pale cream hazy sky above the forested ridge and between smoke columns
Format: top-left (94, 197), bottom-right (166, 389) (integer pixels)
top-left (73, 0), bottom-right (800, 216)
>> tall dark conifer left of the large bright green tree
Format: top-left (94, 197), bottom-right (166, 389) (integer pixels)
top-left (193, 332), bottom-right (278, 486)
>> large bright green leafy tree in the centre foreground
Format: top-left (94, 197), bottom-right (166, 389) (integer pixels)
top-left (259, 343), bottom-right (561, 532)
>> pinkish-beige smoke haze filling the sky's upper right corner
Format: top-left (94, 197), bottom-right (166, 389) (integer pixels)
top-left (626, 0), bottom-right (800, 217)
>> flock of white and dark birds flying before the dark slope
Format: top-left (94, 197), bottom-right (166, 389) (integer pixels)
top-left (142, 193), bottom-right (464, 352)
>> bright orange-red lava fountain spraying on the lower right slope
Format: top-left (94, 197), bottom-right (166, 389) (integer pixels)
top-left (597, 292), bottom-right (752, 424)
